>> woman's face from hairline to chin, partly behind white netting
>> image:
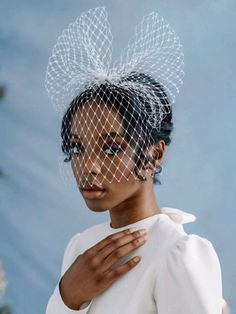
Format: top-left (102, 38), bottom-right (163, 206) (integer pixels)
top-left (70, 100), bottom-right (151, 211)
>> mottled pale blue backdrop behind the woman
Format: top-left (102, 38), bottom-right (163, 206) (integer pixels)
top-left (0, 0), bottom-right (236, 314)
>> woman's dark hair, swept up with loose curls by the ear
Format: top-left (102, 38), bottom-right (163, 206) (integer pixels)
top-left (61, 72), bottom-right (173, 184)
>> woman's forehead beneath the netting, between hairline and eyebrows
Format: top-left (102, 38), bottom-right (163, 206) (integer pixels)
top-left (71, 100), bottom-right (123, 137)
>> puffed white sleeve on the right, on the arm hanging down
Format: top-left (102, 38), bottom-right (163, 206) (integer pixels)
top-left (154, 234), bottom-right (222, 314)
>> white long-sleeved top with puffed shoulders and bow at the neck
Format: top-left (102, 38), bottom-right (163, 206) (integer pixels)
top-left (46, 207), bottom-right (222, 314)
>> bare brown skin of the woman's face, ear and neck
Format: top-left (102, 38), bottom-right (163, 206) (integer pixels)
top-left (71, 99), bottom-right (166, 228)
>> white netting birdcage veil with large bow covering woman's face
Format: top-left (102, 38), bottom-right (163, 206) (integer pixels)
top-left (45, 7), bottom-right (184, 188)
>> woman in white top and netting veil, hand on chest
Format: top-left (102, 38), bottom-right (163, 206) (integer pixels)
top-left (46, 8), bottom-right (222, 314)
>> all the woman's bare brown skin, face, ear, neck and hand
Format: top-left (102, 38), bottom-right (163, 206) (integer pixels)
top-left (59, 100), bottom-right (165, 310)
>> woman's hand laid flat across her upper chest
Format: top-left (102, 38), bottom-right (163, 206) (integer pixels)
top-left (59, 229), bottom-right (146, 310)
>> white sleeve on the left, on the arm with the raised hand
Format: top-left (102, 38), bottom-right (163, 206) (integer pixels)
top-left (45, 233), bottom-right (91, 314)
